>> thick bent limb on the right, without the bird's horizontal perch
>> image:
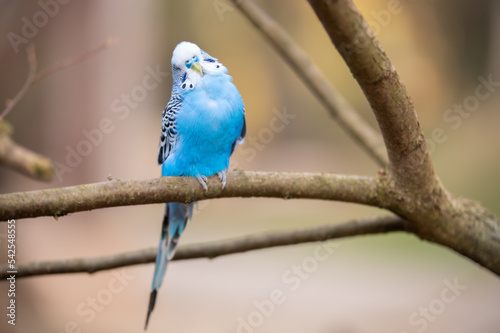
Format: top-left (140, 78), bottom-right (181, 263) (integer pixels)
top-left (309, 0), bottom-right (500, 275)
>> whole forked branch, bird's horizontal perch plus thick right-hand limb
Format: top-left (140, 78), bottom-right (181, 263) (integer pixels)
top-left (0, 0), bottom-right (500, 275)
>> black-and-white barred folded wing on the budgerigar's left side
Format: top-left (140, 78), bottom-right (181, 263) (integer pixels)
top-left (158, 95), bottom-right (182, 165)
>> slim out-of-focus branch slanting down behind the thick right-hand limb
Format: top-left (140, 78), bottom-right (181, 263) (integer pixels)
top-left (232, 0), bottom-right (388, 166)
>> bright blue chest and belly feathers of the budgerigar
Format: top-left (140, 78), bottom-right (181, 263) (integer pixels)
top-left (162, 73), bottom-right (244, 177)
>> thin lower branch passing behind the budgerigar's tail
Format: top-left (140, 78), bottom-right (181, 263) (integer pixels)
top-left (0, 215), bottom-right (405, 279)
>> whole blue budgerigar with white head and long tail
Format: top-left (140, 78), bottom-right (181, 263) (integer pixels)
top-left (145, 42), bottom-right (246, 329)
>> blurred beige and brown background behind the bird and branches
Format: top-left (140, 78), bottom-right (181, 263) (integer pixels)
top-left (0, 0), bottom-right (500, 333)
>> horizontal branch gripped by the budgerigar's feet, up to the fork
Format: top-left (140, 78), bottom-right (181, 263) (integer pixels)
top-left (0, 171), bottom-right (386, 221)
